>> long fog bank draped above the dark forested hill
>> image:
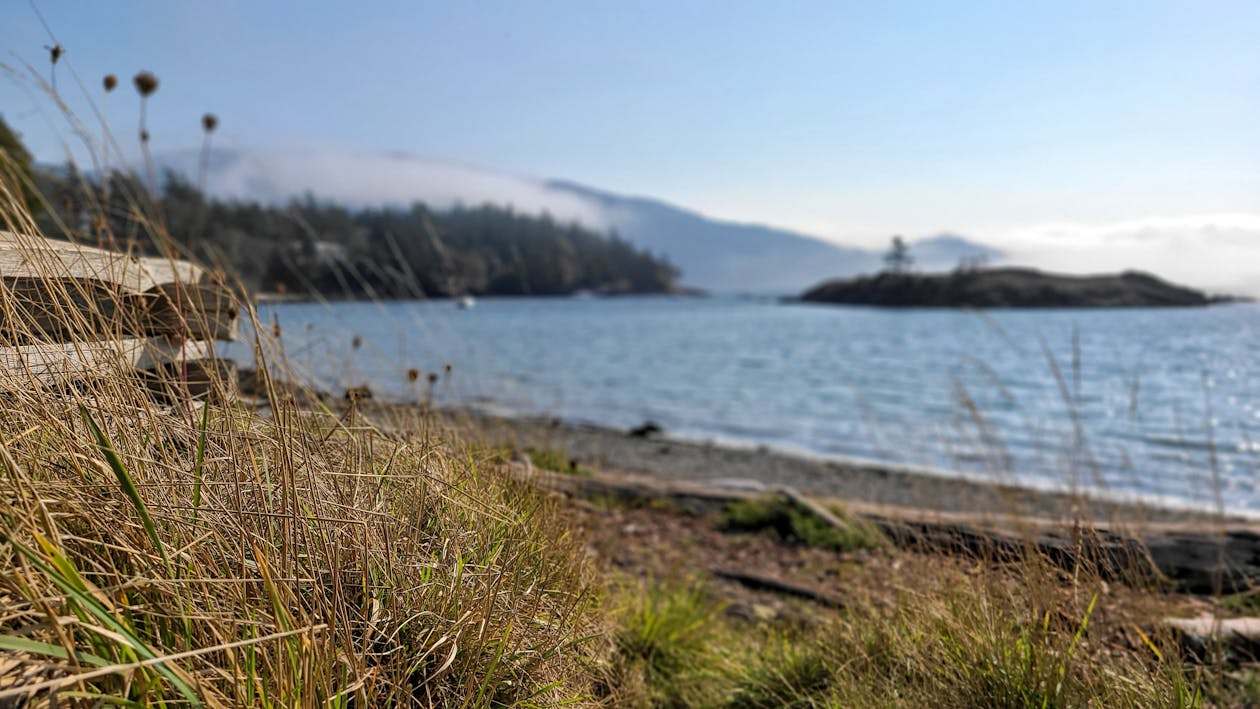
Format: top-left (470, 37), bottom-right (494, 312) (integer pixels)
top-left (177, 147), bottom-right (607, 229)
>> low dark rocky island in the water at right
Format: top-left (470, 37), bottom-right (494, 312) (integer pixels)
top-left (800, 268), bottom-right (1226, 307)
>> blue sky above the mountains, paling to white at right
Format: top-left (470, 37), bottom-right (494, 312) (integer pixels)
top-left (0, 0), bottom-right (1260, 290)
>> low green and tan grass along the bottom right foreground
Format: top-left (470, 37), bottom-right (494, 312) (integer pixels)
top-left (604, 564), bottom-right (1204, 709)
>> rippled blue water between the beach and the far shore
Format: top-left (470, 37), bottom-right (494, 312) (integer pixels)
top-left (240, 297), bottom-right (1260, 513)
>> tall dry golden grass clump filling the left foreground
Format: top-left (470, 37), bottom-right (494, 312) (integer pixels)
top-left (0, 141), bottom-right (606, 706)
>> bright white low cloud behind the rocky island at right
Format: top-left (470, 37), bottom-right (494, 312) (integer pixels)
top-left (984, 214), bottom-right (1260, 296)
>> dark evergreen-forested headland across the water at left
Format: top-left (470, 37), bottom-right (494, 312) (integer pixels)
top-left (27, 170), bottom-right (678, 298)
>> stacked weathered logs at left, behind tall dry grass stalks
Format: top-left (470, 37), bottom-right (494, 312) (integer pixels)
top-left (0, 232), bottom-right (238, 395)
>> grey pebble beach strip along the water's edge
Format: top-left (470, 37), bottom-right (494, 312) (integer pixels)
top-left (440, 408), bottom-right (1244, 526)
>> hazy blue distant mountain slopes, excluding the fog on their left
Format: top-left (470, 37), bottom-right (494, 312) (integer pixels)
top-left (546, 180), bottom-right (1003, 292)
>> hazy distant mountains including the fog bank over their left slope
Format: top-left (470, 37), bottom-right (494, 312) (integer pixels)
top-left (159, 149), bottom-right (1003, 295)
